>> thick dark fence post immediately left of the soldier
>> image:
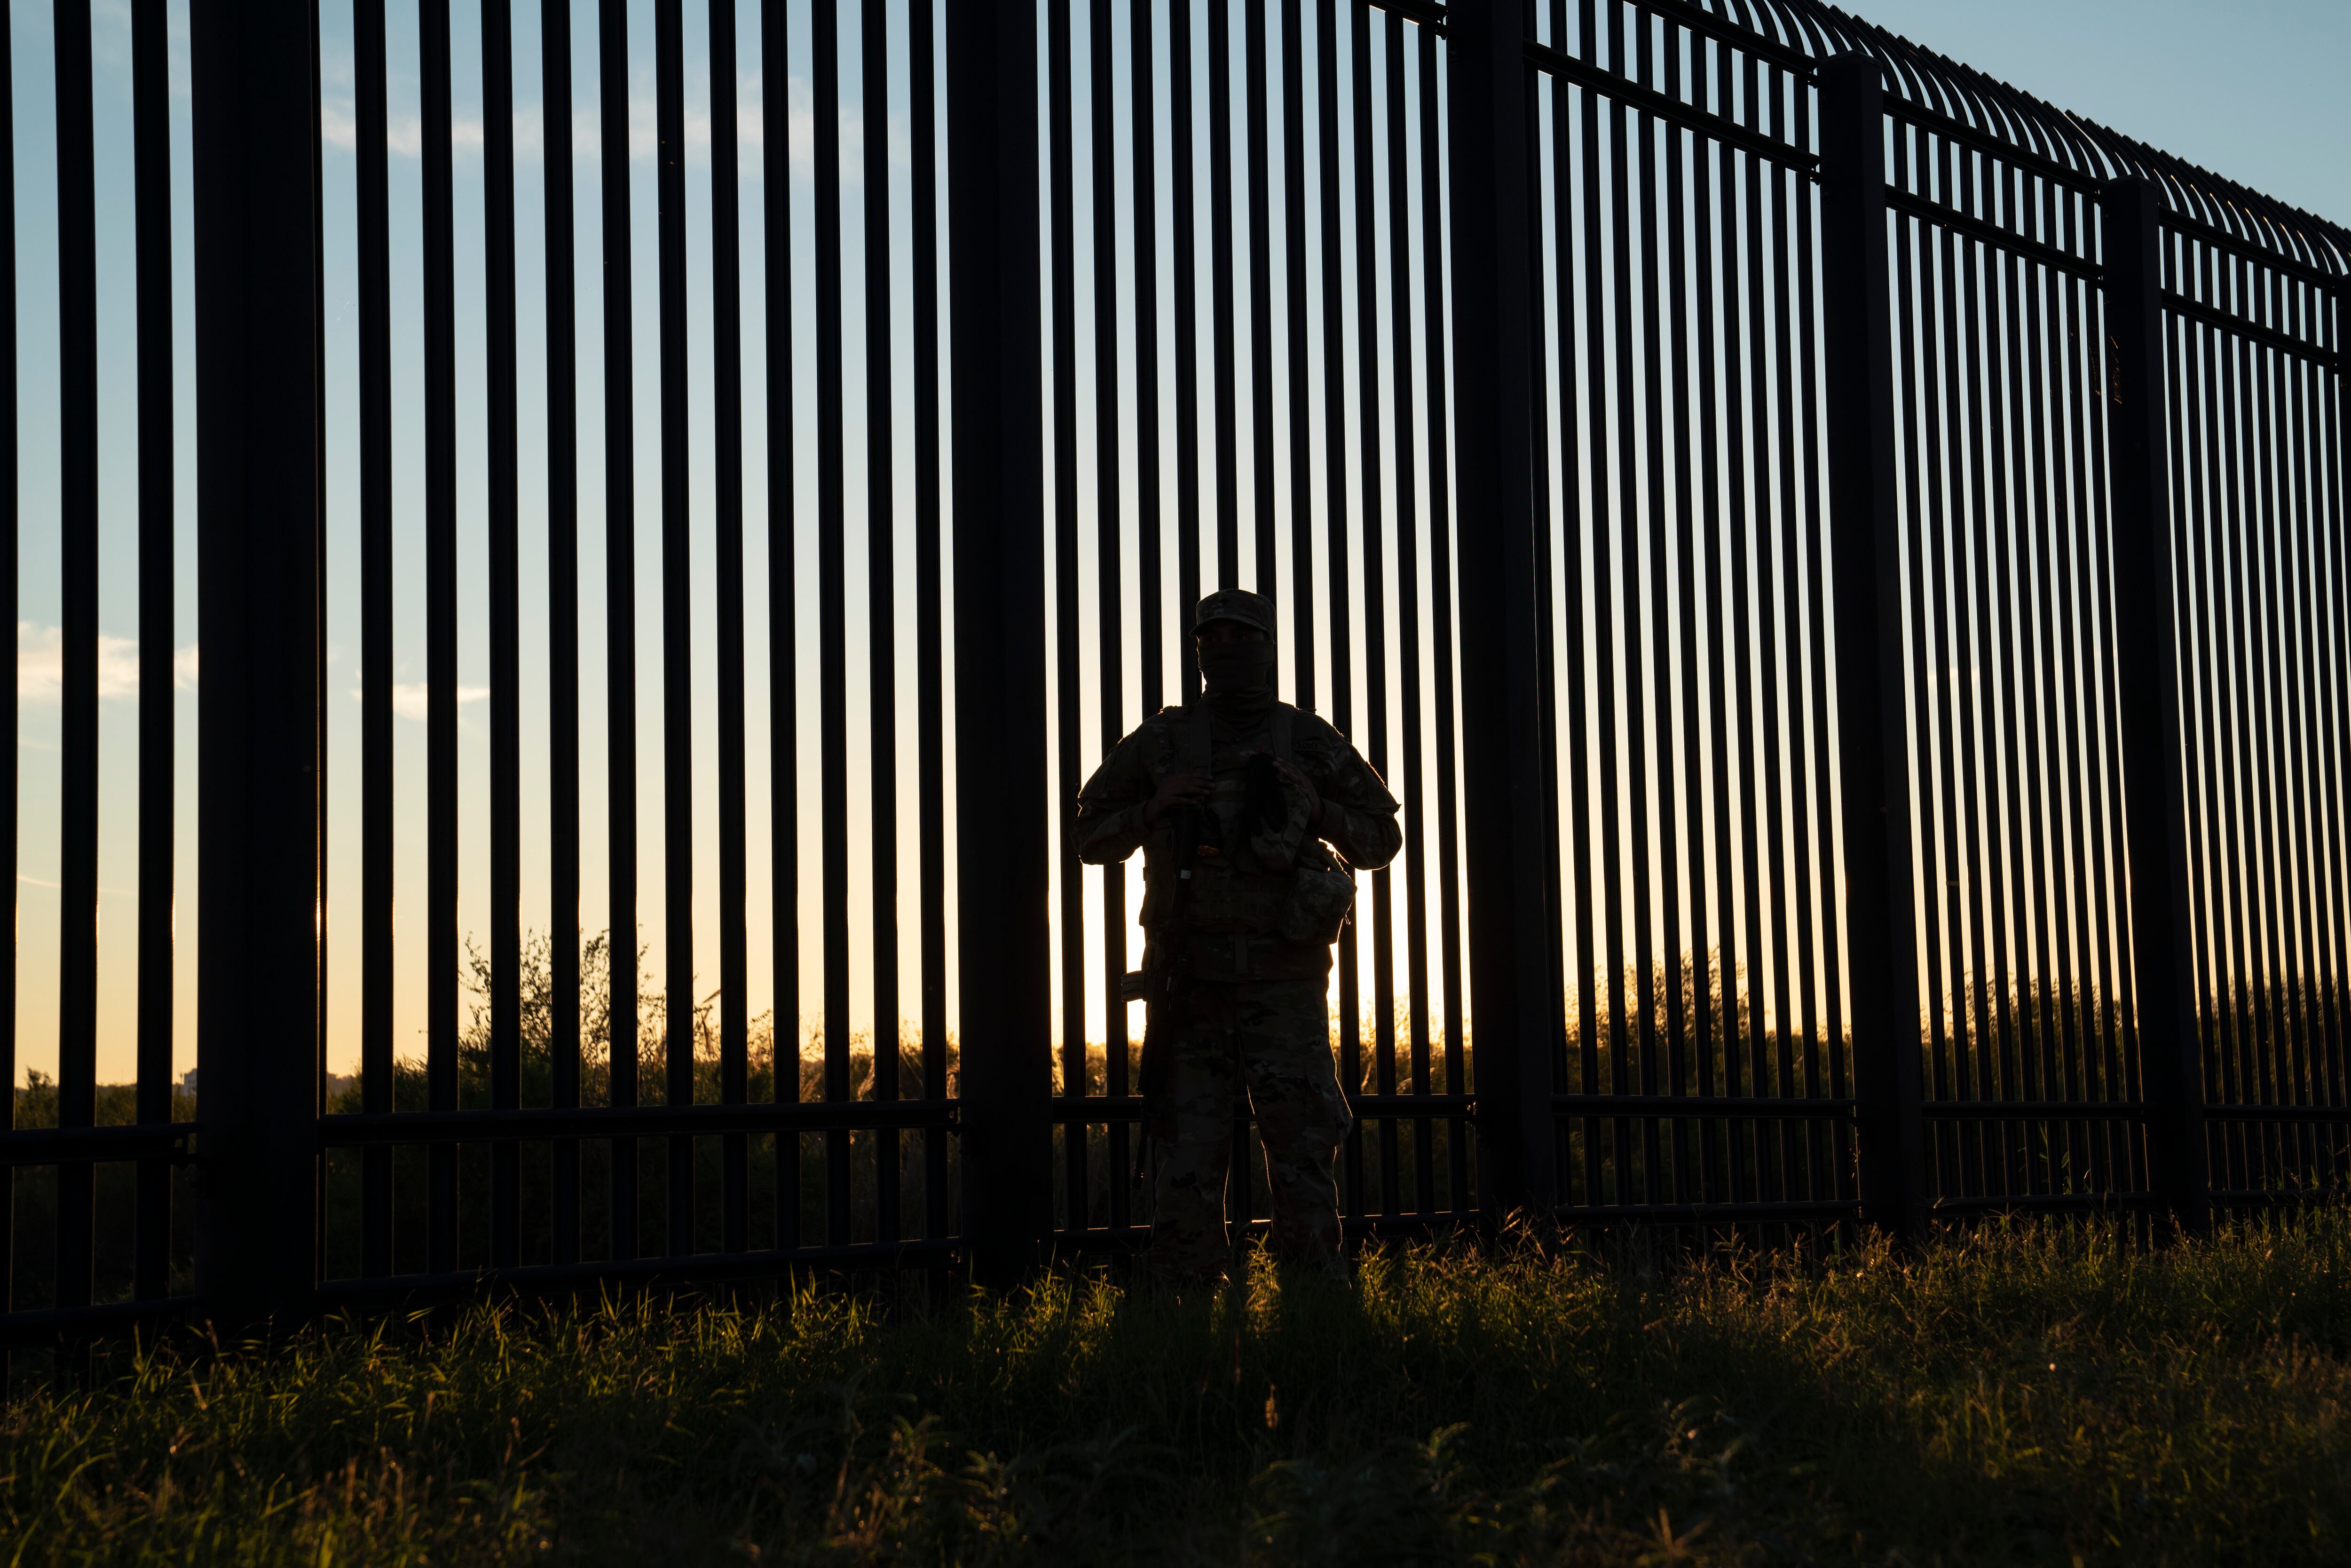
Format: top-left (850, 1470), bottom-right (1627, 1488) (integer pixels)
top-left (947, 0), bottom-right (1053, 1286)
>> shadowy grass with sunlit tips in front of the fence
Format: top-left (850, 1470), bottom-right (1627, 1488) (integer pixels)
top-left (0, 1213), bottom-right (2351, 1568)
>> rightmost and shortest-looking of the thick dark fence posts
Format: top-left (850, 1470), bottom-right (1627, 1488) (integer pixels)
top-left (2099, 179), bottom-right (2212, 1234)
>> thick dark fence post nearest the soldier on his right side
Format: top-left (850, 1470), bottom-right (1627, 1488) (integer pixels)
top-left (1446, 0), bottom-right (1561, 1220)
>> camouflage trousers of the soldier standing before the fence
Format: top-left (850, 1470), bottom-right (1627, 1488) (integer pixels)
top-left (1152, 980), bottom-right (1352, 1276)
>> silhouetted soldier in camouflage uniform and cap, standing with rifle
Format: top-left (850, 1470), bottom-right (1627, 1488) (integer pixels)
top-left (1074, 588), bottom-right (1401, 1284)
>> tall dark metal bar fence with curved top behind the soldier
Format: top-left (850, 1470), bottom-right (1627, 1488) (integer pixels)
top-left (0, 0), bottom-right (2351, 1342)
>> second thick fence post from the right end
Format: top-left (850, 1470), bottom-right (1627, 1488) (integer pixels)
top-left (1820, 54), bottom-right (1925, 1241)
